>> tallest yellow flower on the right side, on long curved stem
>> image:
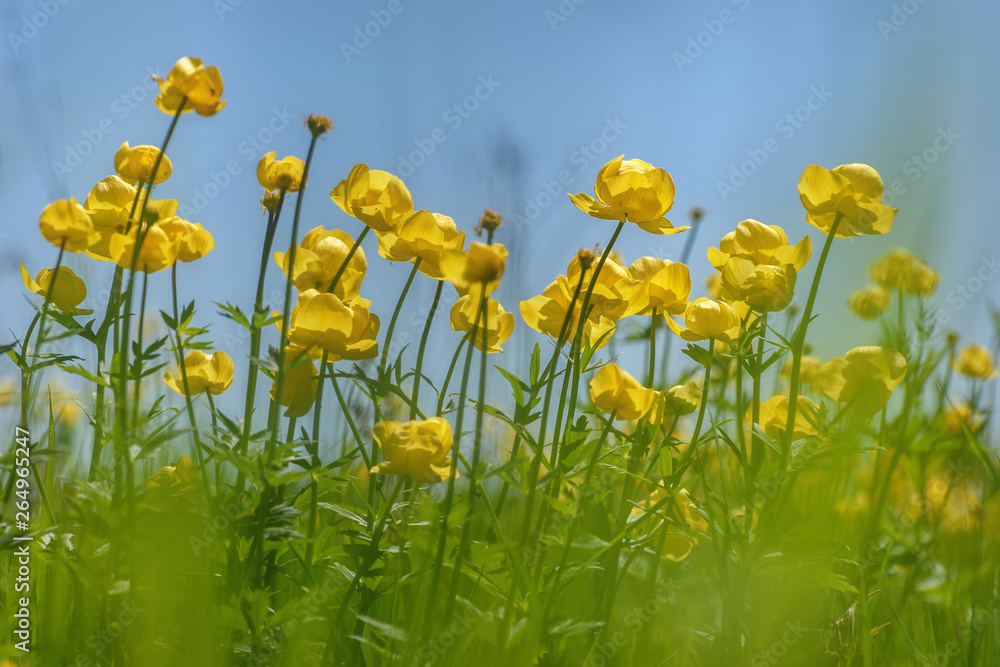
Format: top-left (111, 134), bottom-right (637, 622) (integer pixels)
top-left (799, 164), bottom-right (898, 238)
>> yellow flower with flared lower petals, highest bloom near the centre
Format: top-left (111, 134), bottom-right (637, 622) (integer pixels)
top-left (569, 155), bottom-right (690, 234)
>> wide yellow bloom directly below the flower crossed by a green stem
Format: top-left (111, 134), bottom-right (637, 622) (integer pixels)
top-left (275, 289), bottom-right (379, 361)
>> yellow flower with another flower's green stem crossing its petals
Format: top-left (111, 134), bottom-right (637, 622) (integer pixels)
top-left (274, 226), bottom-right (368, 303)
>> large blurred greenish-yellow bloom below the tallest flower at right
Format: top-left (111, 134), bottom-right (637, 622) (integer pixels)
top-left (813, 345), bottom-right (906, 419)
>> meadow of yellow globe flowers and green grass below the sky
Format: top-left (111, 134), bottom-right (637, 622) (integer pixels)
top-left (0, 57), bottom-right (1000, 667)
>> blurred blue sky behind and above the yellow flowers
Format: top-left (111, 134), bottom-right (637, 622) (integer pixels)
top-left (0, 0), bottom-right (1000, 412)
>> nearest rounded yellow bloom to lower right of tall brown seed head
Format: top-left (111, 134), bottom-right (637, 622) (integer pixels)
top-left (330, 164), bottom-right (413, 234)
